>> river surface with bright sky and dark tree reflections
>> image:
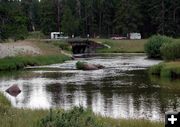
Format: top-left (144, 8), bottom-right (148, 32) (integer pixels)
top-left (0, 55), bottom-right (180, 120)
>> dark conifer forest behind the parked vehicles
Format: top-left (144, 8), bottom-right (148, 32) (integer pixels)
top-left (0, 0), bottom-right (180, 39)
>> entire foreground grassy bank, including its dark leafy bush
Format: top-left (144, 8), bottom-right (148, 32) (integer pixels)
top-left (0, 94), bottom-right (164, 127)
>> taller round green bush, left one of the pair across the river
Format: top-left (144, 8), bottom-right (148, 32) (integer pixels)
top-left (145, 35), bottom-right (173, 58)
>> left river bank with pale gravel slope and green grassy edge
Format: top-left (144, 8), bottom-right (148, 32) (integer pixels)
top-left (0, 40), bottom-right (71, 71)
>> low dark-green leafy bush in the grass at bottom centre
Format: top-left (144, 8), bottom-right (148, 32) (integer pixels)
top-left (40, 107), bottom-right (105, 127)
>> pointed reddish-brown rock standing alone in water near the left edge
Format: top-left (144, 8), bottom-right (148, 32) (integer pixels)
top-left (6, 85), bottom-right (21, 97)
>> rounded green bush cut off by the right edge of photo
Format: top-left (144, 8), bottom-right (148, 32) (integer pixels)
top-left (161, 42), bottom-right (180, 60)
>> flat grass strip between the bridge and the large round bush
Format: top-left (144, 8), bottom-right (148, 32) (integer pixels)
top-left (95, 39), bottom-right (147, 53)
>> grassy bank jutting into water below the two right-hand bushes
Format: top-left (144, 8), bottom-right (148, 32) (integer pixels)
top-left (149, 61), bottom-right (180, 78)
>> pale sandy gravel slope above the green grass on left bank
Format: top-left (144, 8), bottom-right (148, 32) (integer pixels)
top-left (0, 41), bottom-right (41, 58)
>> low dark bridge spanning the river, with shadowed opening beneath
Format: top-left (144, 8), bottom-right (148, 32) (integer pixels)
top-left (67, 39), bottom-right (105, 54)
